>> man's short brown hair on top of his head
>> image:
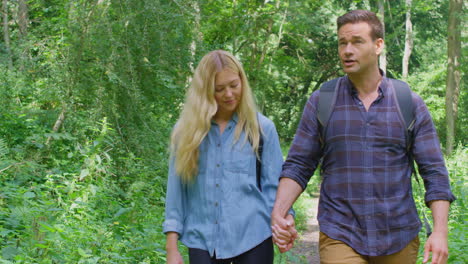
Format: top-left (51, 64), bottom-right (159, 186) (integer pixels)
top-left (336, 10), bottom-right (383, 40)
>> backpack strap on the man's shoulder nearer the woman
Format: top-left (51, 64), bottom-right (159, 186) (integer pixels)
top-left (317, 78), bottom-right (340, 144)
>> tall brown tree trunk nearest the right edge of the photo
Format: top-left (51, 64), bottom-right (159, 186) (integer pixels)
top-left (445, 0), bottom-right (463, 155)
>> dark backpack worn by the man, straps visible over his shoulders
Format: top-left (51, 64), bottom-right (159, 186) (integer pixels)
top-left (317, 78), bottom-right (431, 237)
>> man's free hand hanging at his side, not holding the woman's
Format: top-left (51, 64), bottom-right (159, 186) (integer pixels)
top-left (423, 231), bottom-right (448, 264)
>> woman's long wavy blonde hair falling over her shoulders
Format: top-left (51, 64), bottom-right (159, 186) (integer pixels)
top-left (171, 50), bottom-right (261, 182)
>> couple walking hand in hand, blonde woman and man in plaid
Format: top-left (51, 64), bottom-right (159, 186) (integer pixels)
top-left (163, 10), bottom-right (455, 264)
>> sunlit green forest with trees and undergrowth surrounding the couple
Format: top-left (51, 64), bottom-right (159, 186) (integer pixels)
top-left (0, 0), bottom-right (468, 263)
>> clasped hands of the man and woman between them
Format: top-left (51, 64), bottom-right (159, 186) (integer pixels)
top-left (271, 215), bottom-right (297, 253)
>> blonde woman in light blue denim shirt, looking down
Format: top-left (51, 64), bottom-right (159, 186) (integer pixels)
top-left (163, 50), bottom-right (292, 264)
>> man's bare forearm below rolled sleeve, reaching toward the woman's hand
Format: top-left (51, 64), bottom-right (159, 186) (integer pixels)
top-left (272, 178), bottom-right (302, 218)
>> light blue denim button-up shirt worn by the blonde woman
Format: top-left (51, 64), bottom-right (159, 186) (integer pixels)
top-left (163, 114), bottom-right (283, 258)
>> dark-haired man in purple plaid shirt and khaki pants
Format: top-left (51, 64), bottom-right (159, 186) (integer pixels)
top-left (272, 10), bottom-right (455, 264)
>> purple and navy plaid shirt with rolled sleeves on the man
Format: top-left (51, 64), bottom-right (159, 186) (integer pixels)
top-left (281, 76), bottom-right (455, 256)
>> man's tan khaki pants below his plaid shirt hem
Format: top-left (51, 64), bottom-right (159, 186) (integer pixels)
top-left (319, 232), bottom-right (419, 264)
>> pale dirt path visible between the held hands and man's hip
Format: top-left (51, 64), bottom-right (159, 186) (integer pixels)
top-left (291, 192), bottom-right (320, 264)
